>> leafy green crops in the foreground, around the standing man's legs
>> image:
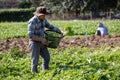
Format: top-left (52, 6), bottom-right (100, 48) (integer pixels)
top-left (0, 47), bottom-right (120, 80)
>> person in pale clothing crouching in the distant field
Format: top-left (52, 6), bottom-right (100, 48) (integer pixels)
top-left (95, 23), bottom-right (108, 36)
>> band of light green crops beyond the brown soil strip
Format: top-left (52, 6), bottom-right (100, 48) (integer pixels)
top-left (0, 20), bottom-right (120, 39)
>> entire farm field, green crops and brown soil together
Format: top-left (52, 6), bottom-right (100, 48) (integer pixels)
top-left (0, 20), bottom-right (120, 80)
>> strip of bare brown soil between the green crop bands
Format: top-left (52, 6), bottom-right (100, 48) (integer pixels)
top-left (0, 34), bottom-right (120, 52)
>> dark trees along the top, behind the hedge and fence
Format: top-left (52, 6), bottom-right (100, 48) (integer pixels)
top-left (0, 0), bottom-right (120, 17)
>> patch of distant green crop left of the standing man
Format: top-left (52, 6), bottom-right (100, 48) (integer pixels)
top-left (0, 22), bottom-right (27, 39)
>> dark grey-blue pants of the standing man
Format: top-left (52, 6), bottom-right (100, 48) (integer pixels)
top-left (30, 41), bottom-right (50, 72)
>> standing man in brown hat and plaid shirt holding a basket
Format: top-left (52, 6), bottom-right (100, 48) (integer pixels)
top-left (28, 6), bottom-right (62, 73)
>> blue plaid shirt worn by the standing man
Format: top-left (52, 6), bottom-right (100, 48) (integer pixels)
top-left (28, 16), bottom-right (58, 38)
